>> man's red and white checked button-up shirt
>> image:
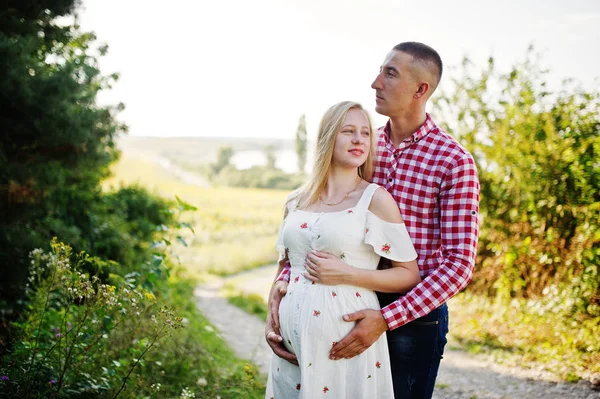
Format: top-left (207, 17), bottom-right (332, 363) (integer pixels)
top-left (278, 115), bottom-right (479, 330)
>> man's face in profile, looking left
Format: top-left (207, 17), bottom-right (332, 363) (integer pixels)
top-left (371, 50), bottom-right (419, 117)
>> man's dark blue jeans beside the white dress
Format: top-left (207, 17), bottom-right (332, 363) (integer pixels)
top-left (380, 296), bottom-right (448, 399)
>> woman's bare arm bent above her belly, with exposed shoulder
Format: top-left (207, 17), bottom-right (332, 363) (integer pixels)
top-left (305, 189), bottom-right (421, 293)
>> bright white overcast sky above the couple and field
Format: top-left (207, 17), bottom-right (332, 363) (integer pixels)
top-left (78, 0), bottom-right (600, 140)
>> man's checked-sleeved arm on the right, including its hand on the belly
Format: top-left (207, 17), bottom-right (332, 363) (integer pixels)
top-left (330, 156), bottom-right (479, 360)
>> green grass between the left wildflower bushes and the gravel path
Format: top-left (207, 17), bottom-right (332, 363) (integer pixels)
top-left (134, 281), bottom-right (265, 399)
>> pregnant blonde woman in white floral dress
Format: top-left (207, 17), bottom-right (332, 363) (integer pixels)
top-left (266, 101), bottom-right (420, 399)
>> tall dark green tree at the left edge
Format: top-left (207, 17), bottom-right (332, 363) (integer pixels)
top-left (0, 0), bottom-right (126, 306)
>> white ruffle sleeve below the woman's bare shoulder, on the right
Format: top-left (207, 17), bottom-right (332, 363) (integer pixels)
top-left (365, 211), bottom-right (417, 262)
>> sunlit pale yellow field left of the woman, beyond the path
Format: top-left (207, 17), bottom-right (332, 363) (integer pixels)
top-left (104, 152), bottom-right (287, 277)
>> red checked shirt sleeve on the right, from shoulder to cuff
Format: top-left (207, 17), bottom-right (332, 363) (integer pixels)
top-left (381, 155), bottom-right (479, 330)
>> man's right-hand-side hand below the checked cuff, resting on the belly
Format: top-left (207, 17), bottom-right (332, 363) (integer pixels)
top-left (329, 309), bottom-right (388, 360)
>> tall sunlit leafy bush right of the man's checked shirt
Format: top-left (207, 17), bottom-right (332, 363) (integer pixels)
top-left (434, 49), bottom-right (600, 316)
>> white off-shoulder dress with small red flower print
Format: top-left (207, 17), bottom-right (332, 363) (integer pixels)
top-left (265, 184), bottom-right (417, 399)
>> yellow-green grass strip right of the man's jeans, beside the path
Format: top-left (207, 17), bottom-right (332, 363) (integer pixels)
top-left (450, 293), bottom-right (600, 382)
